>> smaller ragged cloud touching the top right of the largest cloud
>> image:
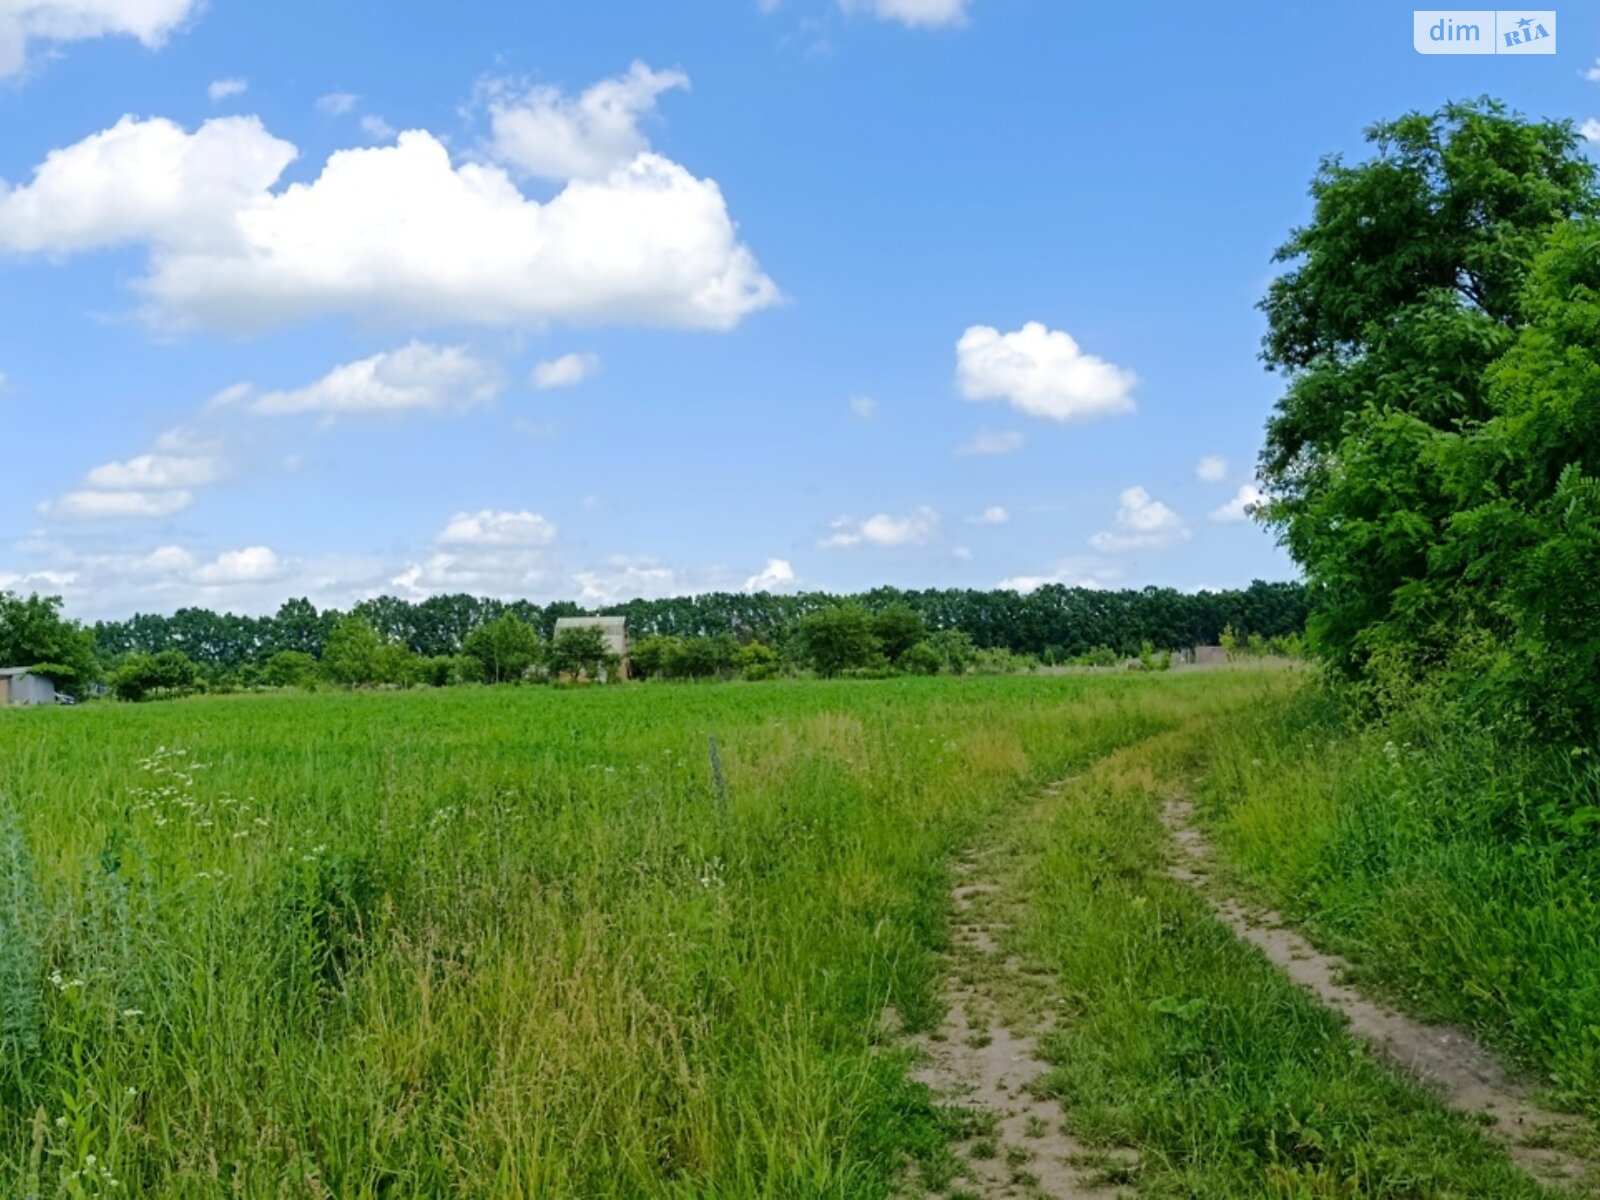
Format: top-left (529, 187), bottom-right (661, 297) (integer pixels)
top-left (490, 62), bottom-right (690, 182)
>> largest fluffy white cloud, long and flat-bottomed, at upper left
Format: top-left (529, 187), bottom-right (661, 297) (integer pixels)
top-left (0, 106), bottom-right (779, 331)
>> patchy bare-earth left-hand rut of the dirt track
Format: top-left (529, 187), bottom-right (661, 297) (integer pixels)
top-left (917, 789), bottom-right (1126, 1200)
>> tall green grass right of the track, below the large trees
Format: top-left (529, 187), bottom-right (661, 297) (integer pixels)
top-left (1203, 686), bottom-right (1600, 1118)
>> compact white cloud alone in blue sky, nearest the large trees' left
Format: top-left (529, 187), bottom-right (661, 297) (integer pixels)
top-left (955, 322), bottom-right (1136, 421)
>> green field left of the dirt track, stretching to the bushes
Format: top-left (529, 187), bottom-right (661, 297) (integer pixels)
top-left (0, 675), bottom-right (1235, 1197)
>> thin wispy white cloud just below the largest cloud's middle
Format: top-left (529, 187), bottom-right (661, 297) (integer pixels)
top-left (251, 342), bottom-right (501, 418)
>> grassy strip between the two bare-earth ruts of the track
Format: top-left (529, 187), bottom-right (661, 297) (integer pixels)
top-left (1010, 729), bottom-right (1549, 1200)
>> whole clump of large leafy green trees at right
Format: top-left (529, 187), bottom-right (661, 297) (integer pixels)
top-left (1261, 99), bottom-right (1600, 741)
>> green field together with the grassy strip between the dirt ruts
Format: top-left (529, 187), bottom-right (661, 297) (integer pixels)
top-left (0, 670), bottom-right (1574, 1200)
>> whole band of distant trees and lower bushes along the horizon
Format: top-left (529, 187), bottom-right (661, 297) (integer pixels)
top-left (0, 582), bottom-right (1306, 699)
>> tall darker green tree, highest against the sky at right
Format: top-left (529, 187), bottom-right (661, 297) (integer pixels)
top-left (1261, 99), bottom-right (1597, 672)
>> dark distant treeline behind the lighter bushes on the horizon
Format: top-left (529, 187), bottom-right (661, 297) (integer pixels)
top-left (93, 581), bottom-right (1307, 669)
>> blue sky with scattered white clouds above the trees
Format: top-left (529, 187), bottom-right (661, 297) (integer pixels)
top-left (0, 0), bottom-right (1600, 618)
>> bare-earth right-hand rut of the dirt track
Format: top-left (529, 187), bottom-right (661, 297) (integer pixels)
top-left (1162, 800), bottom-right (1600, 1195)
